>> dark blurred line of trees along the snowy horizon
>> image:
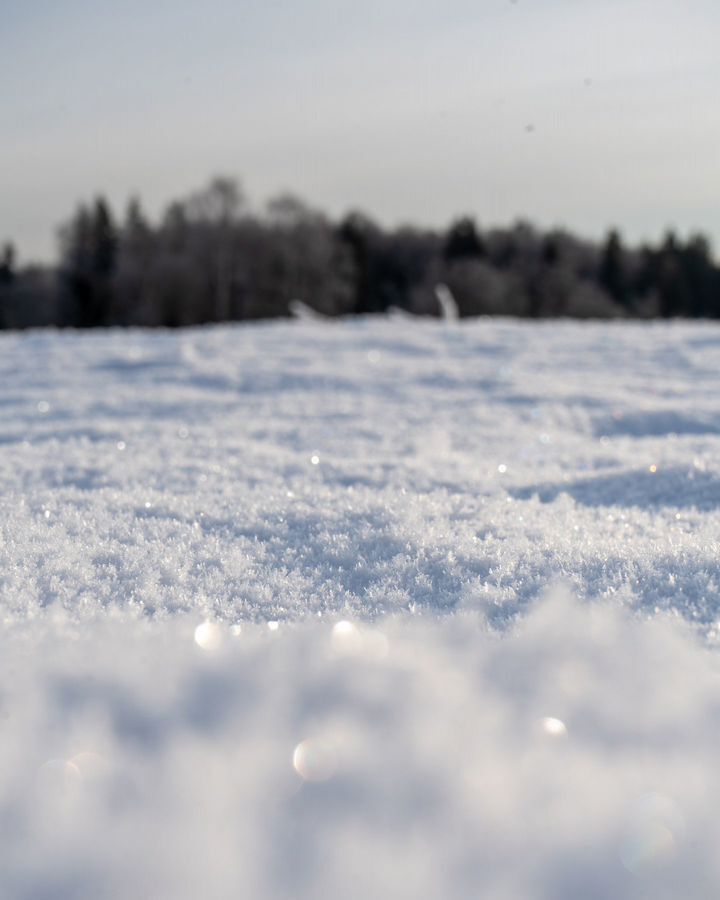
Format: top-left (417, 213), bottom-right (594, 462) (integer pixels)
top-left (0, 178), bottom-right (720, 328)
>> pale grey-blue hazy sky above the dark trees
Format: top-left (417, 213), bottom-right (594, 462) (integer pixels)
top-left (0, 0), bottom-right (720, 260)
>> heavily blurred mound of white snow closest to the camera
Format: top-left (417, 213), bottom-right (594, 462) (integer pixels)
top-left (0, 594), bottom-right (720, 900)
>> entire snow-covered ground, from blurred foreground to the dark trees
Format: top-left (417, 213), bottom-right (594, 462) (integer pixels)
top-left (0, 316), bottom-right (720, 900)
